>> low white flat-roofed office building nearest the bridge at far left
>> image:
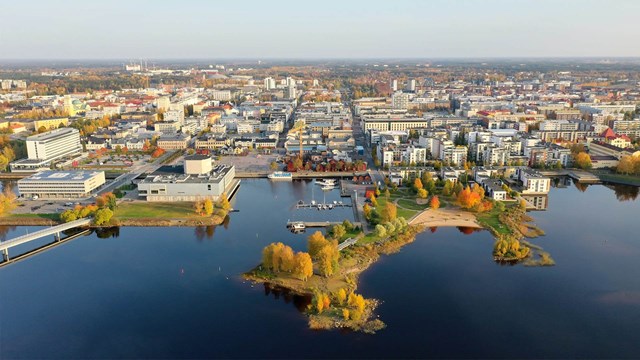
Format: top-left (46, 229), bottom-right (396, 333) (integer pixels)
top-left (18, 170), bottom-right (105, 199)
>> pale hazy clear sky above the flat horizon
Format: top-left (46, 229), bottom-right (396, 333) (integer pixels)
top-left (0, 0), bottom-right (640, 60)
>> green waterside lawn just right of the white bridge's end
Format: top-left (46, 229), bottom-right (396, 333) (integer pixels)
top-left (115, 202), bottom-right (199, 219)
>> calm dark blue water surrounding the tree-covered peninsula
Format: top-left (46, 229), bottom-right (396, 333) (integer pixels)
top-left (0, 180), bottom-right (640, 358)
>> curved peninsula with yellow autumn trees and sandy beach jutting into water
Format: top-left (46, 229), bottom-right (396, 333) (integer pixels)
top-left (243, 176), bottom-right (554, 333)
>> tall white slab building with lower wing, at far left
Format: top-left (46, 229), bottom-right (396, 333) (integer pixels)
top-left (11, 128), bottom-right (82, 171)
